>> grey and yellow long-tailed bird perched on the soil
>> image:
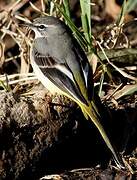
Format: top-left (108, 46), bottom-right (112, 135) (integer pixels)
top-left (24, 16), bottom-right (124, 169)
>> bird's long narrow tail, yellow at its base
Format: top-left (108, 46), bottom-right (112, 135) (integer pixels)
top-left (80, 102), bottom-right (125, 169)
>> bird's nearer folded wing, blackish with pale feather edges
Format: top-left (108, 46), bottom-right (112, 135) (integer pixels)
top-left (33, 48), bottom-right (87, 105)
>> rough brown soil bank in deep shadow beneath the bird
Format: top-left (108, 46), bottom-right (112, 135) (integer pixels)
top-left (0, 91), bottom-right (137, 180)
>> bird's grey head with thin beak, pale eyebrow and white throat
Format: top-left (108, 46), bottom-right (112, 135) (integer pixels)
top-left (26, 16), bottom-right (67, 38)
